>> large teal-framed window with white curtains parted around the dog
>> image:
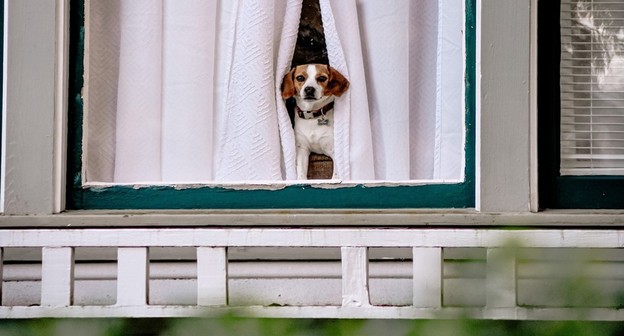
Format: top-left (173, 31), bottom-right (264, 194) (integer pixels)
top-left (68, 0), bottom-right (475, 208)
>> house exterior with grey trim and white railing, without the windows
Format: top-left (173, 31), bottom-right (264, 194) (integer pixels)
top-left (0, 0), bottom-right (624, 320)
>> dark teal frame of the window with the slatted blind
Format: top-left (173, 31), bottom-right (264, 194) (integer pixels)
top-left (537, 0), bottom-right (624, 209)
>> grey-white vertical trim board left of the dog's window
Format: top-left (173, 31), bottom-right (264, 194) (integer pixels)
top-left (2, 0), bottom-right (67, 214)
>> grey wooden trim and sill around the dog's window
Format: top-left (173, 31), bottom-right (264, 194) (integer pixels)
top-left (0, 0), bottom-right (540, 215)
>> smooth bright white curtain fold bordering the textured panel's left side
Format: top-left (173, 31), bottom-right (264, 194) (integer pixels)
top-left (161, 0), bottom-right (217, 182)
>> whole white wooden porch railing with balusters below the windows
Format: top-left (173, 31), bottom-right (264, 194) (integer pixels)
top-left (0, 228), bottom-right (624, 320)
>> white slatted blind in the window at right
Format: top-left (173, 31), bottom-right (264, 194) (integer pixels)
top-left (560, 0), bottom-right (624, 175)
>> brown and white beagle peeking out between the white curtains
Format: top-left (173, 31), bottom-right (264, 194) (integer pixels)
top-left (282, 64), bottom-right (349, 180)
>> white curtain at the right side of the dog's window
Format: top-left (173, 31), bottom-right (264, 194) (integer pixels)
top-left (356, 0), bottom-right (465, 181)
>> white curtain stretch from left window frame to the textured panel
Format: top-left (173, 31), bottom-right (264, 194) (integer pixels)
top-left (85, 0), bottom-right (217, 182)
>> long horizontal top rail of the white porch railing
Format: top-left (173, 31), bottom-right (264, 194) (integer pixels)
top-left (0, 228), bottom-right (624, 248)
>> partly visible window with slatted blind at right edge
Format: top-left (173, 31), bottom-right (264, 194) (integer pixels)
top-left (538, 0), bottom-right (624, 208)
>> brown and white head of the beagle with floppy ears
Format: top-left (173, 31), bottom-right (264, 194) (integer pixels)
top-left (282, 64), bottom-right (349, 104)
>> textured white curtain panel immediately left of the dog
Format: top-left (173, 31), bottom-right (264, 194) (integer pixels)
top-left (215, 0), bottom-right (290, 181)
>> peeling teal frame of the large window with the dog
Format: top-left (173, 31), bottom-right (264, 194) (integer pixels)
top-left (66, 0), bottom-right (476, 210)
